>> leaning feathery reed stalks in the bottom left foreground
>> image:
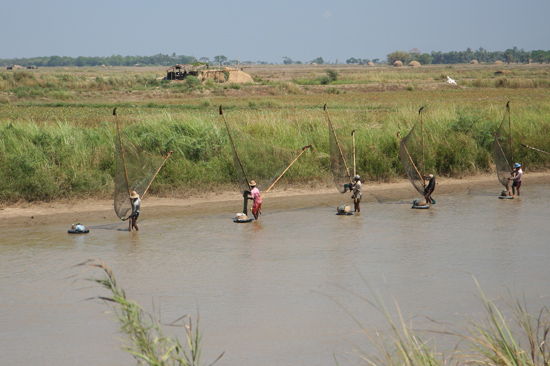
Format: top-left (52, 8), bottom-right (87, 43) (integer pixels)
top-left (80, 260), bottom-right (223, 366)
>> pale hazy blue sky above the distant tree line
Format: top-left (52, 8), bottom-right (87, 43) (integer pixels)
top-left (0, 0), bottom-right (550, 63)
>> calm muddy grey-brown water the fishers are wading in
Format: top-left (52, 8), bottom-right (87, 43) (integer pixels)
top-left (0, 186), bottom-right (550, 366)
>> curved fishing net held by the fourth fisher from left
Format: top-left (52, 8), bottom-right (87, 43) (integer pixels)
top-left (399, 121), bottom-right (425, 195)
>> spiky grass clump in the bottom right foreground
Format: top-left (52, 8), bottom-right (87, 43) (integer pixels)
top-left (340, 282), bottom-right (550, 366)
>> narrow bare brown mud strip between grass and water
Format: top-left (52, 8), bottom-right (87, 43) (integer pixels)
top-left (0, 172), bottom-right (550, 228)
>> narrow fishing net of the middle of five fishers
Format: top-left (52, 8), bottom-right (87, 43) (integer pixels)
top-left (328, 119), bottom-right (353, 193)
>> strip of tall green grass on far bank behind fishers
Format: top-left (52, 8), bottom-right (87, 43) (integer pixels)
top-left (0, 97), bottom-right (550, 201)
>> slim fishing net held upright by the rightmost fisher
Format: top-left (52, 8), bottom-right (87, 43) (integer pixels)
top-left (494, 104), bottom-right (513, 187)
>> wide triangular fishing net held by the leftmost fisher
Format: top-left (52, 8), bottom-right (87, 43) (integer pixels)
top-left (114, 121), bottom-right (167, 219)
